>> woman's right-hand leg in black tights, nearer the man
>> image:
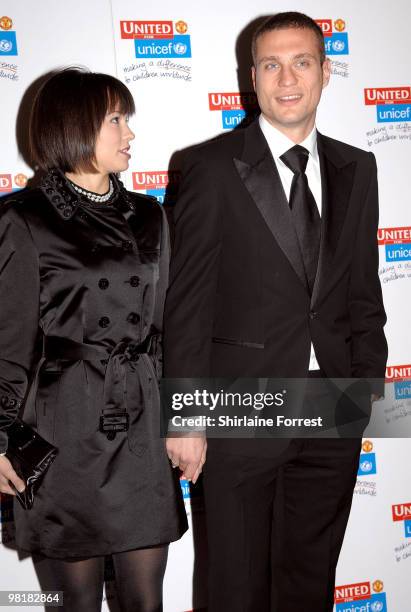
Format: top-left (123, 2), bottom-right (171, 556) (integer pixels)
top-left (113, 545), bottom-right (168, 612)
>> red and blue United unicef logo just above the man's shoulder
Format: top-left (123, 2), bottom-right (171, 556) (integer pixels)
top-left (208, 91), bottom-right (258, 130)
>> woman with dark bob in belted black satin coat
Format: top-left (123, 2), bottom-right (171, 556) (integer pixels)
top-left (0, 69), bottom-right (187, 612)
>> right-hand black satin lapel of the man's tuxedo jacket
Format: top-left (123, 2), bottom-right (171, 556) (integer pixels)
top-left (311, 151), bottom-right (356, 304)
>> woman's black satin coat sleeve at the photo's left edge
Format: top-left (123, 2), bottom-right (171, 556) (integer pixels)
top-left (0, 210), bottom-right (39, 452)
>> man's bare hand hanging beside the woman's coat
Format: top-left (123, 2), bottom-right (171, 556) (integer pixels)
top-left (166, 434), bottom-right (207, 484)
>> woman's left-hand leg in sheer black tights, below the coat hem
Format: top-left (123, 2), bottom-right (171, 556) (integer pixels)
top-left (33, 556), bottom-right (104, 612)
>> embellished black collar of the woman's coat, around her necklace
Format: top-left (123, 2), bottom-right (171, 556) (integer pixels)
top-left (40, 168), bottom-right (135, 221)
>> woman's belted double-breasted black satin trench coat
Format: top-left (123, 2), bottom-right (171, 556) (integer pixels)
top-left (0, 171), bottom-right (187, 558)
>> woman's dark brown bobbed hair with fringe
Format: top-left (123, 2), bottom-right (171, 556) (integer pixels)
top-left (29, 68), bottom-right (135, 172)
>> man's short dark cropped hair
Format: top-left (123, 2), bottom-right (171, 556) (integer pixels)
top-left (251, 11), bottom-right (325, 66)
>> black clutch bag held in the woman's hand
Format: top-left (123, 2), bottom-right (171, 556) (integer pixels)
top-left (6, 419), bottom-right (58, 510)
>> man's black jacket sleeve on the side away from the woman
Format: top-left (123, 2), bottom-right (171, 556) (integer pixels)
top-left (348, 153), bottom-right (388, 395)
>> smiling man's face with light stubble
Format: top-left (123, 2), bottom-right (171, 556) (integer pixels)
top-left (252, 28), bottom-right (330, 139)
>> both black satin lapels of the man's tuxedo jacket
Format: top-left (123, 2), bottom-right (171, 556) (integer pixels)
top-left (233, 119), bottom-right (356, 304)
